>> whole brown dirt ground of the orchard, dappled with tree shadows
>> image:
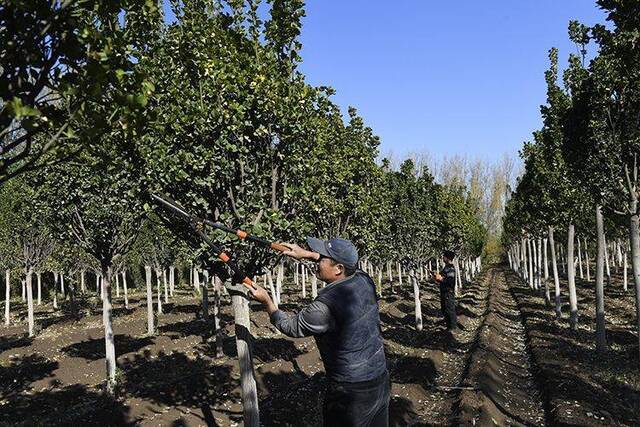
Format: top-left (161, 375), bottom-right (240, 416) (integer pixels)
top-left (0, 266), bottom-right (640, 426)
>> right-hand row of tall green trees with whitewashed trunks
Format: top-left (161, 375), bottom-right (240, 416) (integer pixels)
top-left (503, 0), bottom-right (640, 362)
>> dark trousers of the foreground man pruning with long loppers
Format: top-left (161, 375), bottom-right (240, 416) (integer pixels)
top-left (322, 372), bottom-right (391, 427)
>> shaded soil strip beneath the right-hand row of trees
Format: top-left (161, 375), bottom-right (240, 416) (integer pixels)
top-left (503, 267), bottom-right (640, 426)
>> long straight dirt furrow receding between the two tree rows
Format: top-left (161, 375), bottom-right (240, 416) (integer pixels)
top-left (453, 267), bottom-right (546, 426)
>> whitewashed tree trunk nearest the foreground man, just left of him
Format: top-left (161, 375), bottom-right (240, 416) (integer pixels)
top-left (231, 295), bottom-right (260, 427)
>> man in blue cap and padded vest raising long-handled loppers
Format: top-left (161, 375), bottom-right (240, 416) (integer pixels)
top-left (252, 237), bottom-right (390, 426)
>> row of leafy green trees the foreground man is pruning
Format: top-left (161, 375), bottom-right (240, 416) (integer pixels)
top-left (0, 0), bottom-right (486, 425)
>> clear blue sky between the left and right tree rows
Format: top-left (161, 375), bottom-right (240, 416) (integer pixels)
top-left (301, 0), bottom-right (604, 160)
